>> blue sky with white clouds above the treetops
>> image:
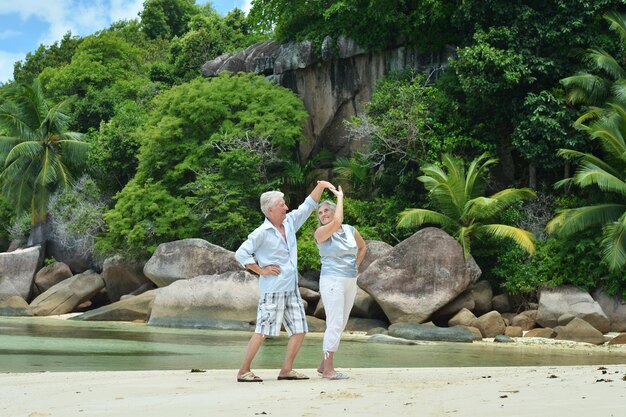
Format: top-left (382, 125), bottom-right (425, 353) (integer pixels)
top-left (0, 0), bottom-right (251, 83)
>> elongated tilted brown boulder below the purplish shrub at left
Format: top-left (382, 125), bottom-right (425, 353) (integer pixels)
top-left (30, 270), bottom-right (104, 316)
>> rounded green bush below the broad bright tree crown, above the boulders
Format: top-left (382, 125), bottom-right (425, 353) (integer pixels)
top-left (96, 179), bottom-right (200, 260)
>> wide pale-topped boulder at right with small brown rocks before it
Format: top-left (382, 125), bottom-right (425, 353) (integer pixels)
top-left (537, 285), bottom-right (610, 333)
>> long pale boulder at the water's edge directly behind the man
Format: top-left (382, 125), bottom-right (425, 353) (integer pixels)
top-left (148, 270), bottom-right (259, 330)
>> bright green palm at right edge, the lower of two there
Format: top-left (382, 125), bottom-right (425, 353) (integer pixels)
top-left (546, 104), bottom-right (626, 271)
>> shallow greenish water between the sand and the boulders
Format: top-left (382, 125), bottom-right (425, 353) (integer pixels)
top-left (0, 317), bottom-right (626, 372)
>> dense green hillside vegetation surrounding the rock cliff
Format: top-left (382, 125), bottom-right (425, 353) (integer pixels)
top-left (0, 0), bottom-right (626, 298)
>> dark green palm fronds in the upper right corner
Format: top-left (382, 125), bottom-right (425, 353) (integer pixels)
top-left (561, 12), bottom-right (626, 123)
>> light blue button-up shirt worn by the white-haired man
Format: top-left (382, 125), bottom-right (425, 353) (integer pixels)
top-left (235, 196), bottom-right (317, 294)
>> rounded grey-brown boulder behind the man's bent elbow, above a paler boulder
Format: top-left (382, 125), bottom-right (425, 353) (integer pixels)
top-left (143, 239), bottom-right (243, 287)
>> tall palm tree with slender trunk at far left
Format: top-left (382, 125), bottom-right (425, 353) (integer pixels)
top-left (0, 80), bottom-right (88, 244)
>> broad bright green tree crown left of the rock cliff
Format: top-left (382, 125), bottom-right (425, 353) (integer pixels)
top-left (137, 73), bottom-right (306, 189)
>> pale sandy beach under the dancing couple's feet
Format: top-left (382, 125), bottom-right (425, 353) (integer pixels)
top-left (0, 365), bottom-right (626, 417)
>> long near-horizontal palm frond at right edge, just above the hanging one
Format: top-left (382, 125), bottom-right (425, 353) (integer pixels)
top-left (546, 204), bottom-right (626, 236)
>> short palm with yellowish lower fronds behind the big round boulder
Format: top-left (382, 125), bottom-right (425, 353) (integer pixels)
top-left (398, 154), bottom-right (535, 257)
